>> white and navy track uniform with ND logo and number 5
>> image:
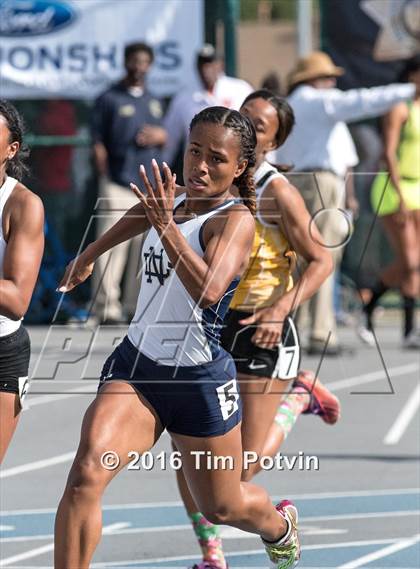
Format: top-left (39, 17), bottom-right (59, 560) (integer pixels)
top-left (101, 195), bottom-right (242, 437)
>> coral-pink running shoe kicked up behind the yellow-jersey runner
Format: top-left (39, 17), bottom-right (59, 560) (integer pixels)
top-left (293, 370), bottom-right (340, 425)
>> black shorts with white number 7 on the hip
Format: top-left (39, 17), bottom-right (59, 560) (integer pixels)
top-left (221, 310), bottom-right (301, 380)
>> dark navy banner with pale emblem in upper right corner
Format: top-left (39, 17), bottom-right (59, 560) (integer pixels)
top-left (320, 0), bottom-right (420, 89)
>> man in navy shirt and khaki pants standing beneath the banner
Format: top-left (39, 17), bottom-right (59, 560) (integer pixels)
top-left (92, 43), bottom-right (166, 322)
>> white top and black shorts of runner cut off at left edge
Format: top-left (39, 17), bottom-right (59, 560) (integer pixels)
top-left (0, 176), bottom-right (31, 398)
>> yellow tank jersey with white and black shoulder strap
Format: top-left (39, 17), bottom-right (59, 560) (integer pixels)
top-left (230, 161), bottom-right (296, 312)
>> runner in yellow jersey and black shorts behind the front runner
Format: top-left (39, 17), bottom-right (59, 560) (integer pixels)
top-left (177, 90), bottom-right (339, 569)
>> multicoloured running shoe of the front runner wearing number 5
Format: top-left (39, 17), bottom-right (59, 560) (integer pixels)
top-left (262, 500), bottom-right (300, 569)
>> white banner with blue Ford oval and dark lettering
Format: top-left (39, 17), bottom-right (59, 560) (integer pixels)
top-left (0, 0), bottom-right (204, 99)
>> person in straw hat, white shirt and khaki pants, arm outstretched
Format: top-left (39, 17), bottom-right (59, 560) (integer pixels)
top-left (270, 51), bottom-right (415, 355)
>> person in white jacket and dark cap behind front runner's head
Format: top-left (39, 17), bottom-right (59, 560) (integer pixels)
top-left (163, 44), bottom-right (254, 166)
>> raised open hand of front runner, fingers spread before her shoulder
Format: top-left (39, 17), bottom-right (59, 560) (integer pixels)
top-left (130, 160), bottom-right (176, 234)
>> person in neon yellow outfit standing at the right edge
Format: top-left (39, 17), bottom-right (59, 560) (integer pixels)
top-left (359, 55), bottom-right (420, 349)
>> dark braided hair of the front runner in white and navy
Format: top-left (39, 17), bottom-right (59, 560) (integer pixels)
top-left (190, 107), bottom-right (257, 215)
